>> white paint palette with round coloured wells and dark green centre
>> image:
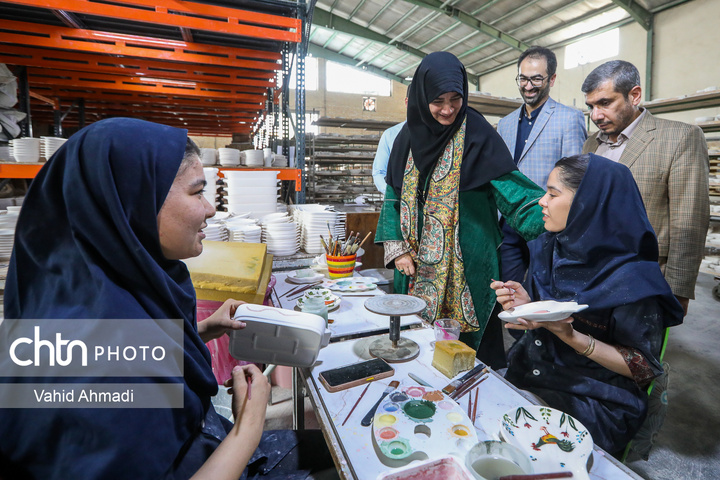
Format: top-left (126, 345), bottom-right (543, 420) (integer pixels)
top-left (373, 386), bottom-right (478, 460)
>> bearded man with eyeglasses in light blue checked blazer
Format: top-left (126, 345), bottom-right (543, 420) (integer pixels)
top-left (498, 47), bottom-right (587, 282)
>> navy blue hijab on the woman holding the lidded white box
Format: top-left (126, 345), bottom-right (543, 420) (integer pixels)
top-left (0, 118), bottom-right (217, 478)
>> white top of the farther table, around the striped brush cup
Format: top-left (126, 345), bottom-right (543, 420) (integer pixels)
top-left (272, 272), bottom-right (422, 342)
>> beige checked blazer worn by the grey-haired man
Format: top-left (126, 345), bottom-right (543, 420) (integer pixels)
top-left (582, 112), bottom-right (710, 298)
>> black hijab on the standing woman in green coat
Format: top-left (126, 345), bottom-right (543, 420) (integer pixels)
top-left (386, 52), bottom-right (517, 196)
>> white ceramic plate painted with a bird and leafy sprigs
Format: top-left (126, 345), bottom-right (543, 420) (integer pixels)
top-left (500, 405), bottom-right (593, 479)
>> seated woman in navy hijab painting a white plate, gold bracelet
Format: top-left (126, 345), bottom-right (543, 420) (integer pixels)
top-left (491, 154), bottom-right (683, 454)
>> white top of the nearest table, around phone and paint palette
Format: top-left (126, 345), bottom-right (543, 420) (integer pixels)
top-left (303, 328), bottom-right (640, 480)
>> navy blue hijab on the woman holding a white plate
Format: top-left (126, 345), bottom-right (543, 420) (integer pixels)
top-left (527, 153), bottom-right (683, 327)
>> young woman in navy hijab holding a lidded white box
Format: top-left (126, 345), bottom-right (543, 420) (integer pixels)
top-left (0, 118), bottom-right (330, 480)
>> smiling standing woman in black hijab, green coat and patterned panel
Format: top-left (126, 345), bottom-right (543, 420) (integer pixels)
top-left (375, 52), bottom-right (543, 368)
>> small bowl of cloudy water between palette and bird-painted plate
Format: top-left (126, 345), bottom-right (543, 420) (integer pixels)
top-left (465, 440), bottom-right (533, 480)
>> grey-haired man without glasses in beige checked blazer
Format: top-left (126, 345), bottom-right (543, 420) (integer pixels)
top-left (582, 60), bottom-right (710, 314)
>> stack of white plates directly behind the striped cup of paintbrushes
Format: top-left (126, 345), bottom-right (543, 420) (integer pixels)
top-left (293, 205), bottom-right (346, 253)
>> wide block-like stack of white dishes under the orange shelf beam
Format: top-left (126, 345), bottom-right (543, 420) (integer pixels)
top-left (223, 170), bottom-right (278, 218)
